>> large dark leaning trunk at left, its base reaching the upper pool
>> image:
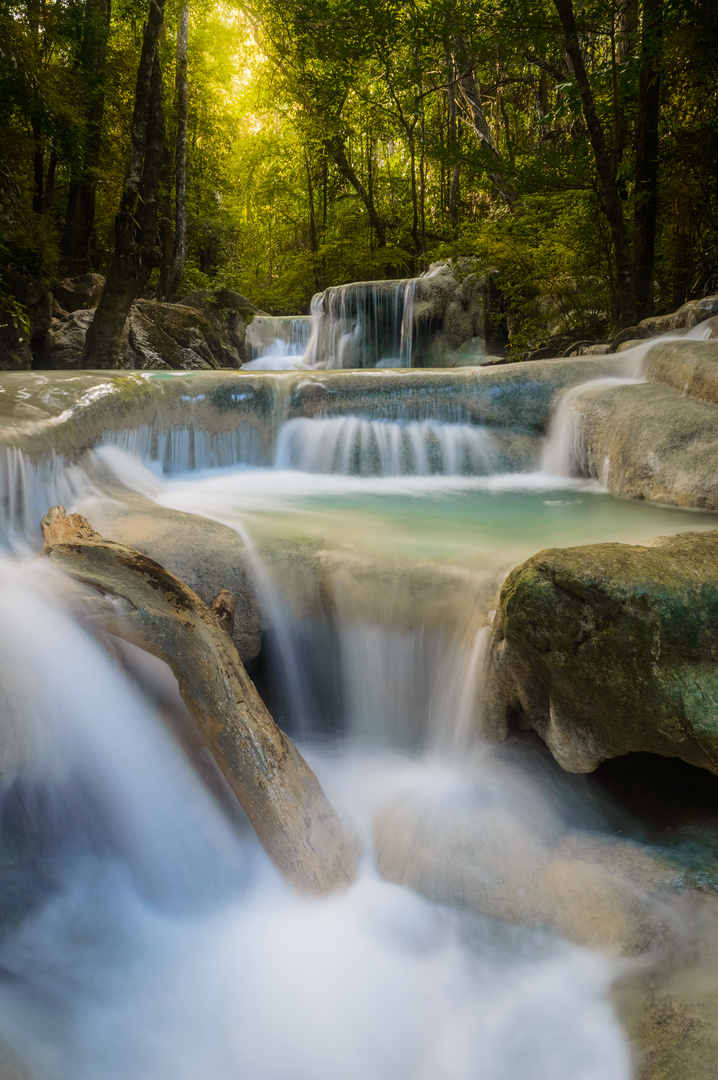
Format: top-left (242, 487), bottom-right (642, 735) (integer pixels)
top-left (83, 0), bottom-right (164, 368)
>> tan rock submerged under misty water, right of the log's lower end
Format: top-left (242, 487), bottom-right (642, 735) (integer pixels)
top-left (374, 793), bottom-right (672, 956)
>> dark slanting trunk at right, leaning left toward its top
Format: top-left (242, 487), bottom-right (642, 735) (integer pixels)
top-left (554, 0), bottom-right (636, 330)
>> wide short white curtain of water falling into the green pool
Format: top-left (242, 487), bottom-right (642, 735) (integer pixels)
top-left (274, 416), bottom-right (497, 476)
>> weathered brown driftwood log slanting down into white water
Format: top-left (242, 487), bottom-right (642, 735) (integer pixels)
top-left (42, 507), bottom-right (357, 894)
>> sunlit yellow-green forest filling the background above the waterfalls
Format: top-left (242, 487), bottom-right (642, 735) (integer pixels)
top-left (0, 0), bottom-right (718, 350)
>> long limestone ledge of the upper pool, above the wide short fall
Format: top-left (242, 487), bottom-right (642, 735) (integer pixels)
top-left (0, 356), bottom-right (621, 460)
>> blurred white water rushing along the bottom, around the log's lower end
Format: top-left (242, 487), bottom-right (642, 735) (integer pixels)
top-left (0, 562), bottom-right (628, 1080)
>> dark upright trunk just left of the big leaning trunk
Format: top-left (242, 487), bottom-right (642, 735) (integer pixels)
top-left (63, 0), bottom-right (111, 274)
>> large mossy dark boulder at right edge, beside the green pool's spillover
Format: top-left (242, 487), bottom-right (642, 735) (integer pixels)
top-left (480, 531), bottom-right (718, 774)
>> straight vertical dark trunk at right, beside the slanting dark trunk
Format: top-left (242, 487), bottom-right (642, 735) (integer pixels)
top-left (634, 0), bottom-right (663, 319)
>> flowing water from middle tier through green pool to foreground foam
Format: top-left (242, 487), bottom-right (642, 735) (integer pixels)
top-left (0, 367), bottom-right (718, 1080)
